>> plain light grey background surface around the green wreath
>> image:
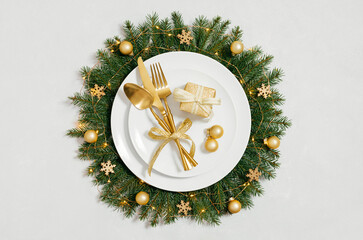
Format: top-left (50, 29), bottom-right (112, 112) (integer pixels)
top-left (0, 0), bottom-right (363, 240)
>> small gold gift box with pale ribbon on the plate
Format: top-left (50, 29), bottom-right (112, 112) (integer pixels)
top-left (173, 82), bottom-right (221, 118)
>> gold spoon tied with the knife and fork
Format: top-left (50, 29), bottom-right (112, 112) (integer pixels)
top-left (124, 83), bottom-right (192, 170)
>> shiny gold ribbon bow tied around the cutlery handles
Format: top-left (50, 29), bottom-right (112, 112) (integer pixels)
top-left (147, 118), bottom-right (195, 176)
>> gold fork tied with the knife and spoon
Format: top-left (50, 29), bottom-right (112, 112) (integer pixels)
top-left (150, 63), bottom-right (198, 170)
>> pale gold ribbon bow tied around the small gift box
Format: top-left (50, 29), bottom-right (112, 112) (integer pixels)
top-left (173, 85), bottom-right (221, 115)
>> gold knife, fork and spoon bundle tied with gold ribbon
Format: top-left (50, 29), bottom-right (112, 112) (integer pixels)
top-left (124, 57), bottom-right (198, 175)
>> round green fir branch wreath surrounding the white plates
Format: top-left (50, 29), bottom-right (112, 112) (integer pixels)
top-left (67, 12), bottom-right (290, 226)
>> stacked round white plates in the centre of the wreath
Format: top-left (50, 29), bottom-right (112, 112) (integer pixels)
top-left (111, 52), bottom-right (251, 191)
